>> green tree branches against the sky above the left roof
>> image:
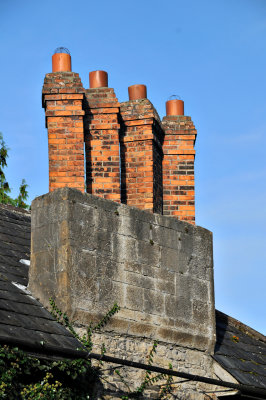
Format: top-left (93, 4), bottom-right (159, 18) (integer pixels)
top-left (0, 132), bottom-right (29, 208)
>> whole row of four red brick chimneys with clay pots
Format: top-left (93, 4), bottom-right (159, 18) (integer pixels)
top-left (43, 47), bottom-right (200, 224)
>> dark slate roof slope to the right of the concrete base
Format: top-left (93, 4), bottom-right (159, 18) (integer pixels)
top-left (214, 311), bottom-right (266, 389)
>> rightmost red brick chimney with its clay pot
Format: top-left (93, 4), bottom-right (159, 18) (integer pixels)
top-left (162, 99), bottom-right (197, 224)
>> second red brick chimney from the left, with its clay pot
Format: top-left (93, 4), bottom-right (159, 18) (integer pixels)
top-left (84, 71), bottom-right (121, 202)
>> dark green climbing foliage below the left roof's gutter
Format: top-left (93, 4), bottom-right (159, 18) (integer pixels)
top-left (0, 346), bottom-right (97, 400)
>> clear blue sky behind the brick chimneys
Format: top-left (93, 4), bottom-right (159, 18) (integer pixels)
top-left (0, 0), bottom-right (266, 334)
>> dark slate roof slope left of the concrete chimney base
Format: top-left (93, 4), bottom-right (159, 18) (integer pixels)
top-left (0, 205), bottom-right (84, 357)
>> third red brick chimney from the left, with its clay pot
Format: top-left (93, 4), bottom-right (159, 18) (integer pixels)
top-left (120, 85), bottom-right (164, 214)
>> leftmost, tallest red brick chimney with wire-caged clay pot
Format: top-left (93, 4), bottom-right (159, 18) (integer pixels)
top-left (42, 48), bottom-right (85, 191)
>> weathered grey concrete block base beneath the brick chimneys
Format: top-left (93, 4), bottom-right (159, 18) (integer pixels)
top-left (29, 188), bottom-right (215, 352)
